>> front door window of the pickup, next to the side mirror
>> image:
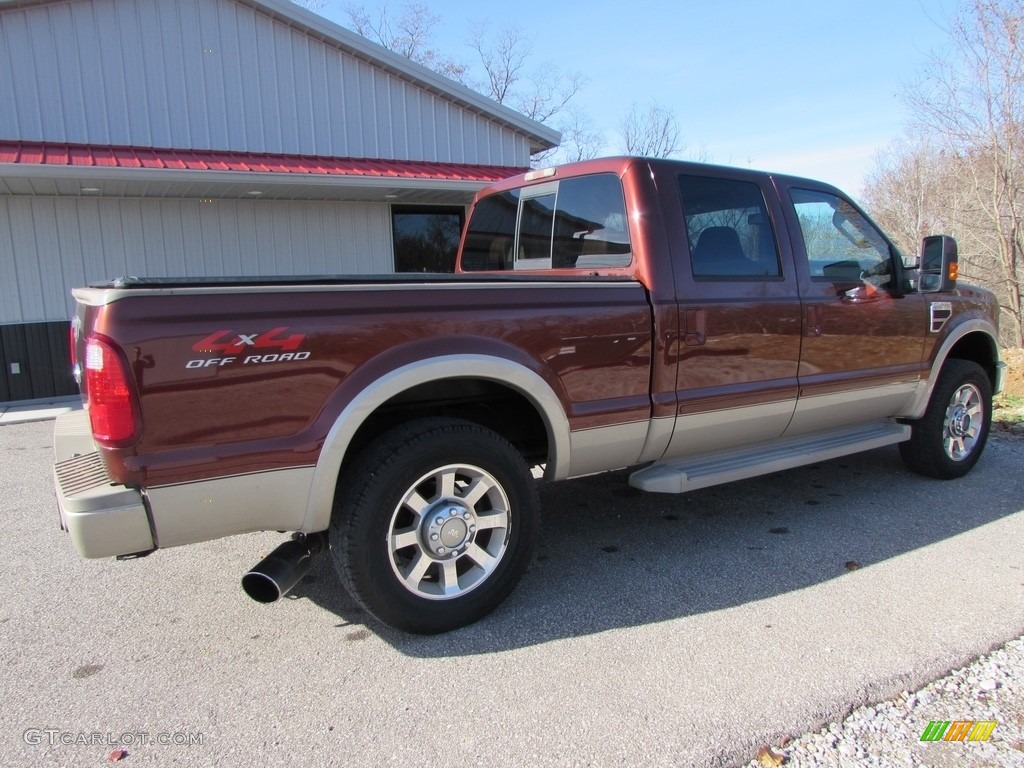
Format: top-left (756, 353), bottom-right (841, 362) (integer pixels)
top-left (790, 189), bottom-right (893, 288)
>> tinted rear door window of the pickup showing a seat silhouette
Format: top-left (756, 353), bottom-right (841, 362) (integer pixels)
top-left (679, 176), bottom-right (782, 280)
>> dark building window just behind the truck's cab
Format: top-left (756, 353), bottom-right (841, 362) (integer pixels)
top-left (391, 206), bottom-right (466, 272)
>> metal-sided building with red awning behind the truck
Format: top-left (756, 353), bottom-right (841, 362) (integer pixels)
top-left (0, 0), bottom-right (559, 401)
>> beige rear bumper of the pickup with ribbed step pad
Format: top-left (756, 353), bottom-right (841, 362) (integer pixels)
top-left (53, 411), bottom-right (155, 557)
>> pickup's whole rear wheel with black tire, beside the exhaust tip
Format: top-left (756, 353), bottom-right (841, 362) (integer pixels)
top-left (331, 419), bottom-right (540, 634)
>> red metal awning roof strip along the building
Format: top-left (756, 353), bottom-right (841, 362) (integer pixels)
top-left (0, 140), bottom-right (527, 182)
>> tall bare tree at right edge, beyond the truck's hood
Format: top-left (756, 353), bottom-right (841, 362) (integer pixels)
top-left (908, 0), bottom-right (1024, 346)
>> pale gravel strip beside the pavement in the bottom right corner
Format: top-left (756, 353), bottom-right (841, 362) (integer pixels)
top-left (748, 637), bottom-right (1024, 768)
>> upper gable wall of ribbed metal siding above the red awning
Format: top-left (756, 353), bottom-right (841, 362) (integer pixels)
top-left (0, 0), bottom-right (529, 167)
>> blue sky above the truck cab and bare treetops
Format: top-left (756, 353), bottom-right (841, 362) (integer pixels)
top-left (319, 0), bottom-right (956, 194)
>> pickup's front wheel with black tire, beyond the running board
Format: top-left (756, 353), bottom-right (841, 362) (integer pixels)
top-left (899, 359), bottom-right (992, 480)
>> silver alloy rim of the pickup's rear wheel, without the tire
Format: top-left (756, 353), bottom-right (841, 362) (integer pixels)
top-left (388, 464), bottom-right (510, 600)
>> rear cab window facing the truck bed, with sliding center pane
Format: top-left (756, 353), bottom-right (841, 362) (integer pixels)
top-left (462, 174), bottom-right (633, 271)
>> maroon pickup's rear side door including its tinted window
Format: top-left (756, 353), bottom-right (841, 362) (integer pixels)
top-left (658, 169), bottom-right (802, 458)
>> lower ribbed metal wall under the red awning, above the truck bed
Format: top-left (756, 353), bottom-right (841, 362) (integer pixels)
top-left (0, 196), bottom-right (394, 324)
